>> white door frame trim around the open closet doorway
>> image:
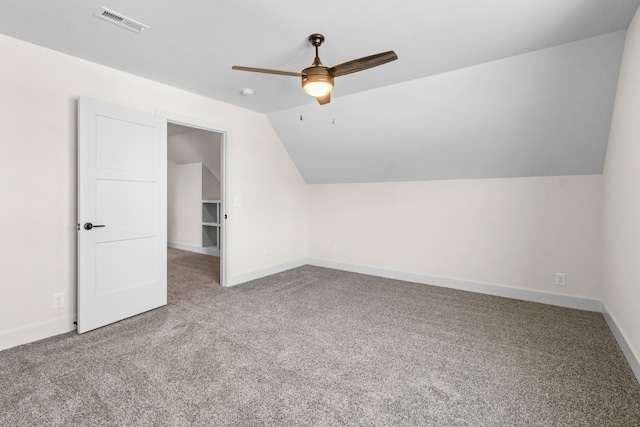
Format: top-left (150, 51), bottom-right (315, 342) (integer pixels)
top-left (156, 110), bottom-right (231, 286)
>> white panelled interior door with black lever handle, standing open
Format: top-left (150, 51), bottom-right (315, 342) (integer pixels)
top-left (77, 98), bottom-right (167, 333)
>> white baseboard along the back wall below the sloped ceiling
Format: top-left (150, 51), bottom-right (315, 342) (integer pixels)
top-left (308, 258), bottom-right (602, 312)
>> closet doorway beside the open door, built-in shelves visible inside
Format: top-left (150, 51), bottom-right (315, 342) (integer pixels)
top-left (167, 115), bottom-right (228, 286)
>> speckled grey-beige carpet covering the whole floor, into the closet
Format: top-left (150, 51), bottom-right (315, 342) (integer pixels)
top-left (0, 249), bottom-right (640, 426)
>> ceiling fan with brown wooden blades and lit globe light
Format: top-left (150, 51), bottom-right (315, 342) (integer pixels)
top-left (231, 34), bottom-right (398, 105)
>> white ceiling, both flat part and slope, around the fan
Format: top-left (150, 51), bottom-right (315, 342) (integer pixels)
top-left (0, 0), bottom-right (640, 183)
